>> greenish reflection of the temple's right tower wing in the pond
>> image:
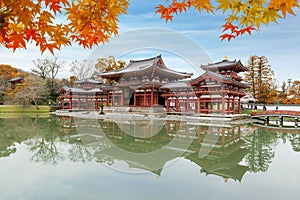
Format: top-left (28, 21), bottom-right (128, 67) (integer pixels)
top-left (166, 122), bottom-right (248, 181)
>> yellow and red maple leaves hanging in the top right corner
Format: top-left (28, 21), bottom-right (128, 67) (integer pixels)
top-left (156, 0), bottom-right (299, 41)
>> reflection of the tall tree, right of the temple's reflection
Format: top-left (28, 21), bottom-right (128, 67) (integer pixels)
top-left (245, 129), bottom-right (277, 172)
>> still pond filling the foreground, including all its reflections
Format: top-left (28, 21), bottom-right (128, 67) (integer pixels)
top-left (0, 116), bottom-right (300, 200)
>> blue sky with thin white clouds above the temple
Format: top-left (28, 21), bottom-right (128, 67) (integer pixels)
top-left (0, 0), bottom-right (300, 84)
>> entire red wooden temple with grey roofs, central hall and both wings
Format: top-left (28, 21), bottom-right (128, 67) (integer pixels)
top-left (59, 55), bottom-right (248, 115)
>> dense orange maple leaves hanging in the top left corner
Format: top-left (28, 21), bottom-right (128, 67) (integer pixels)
top-left (0, 0), bottom-right (128, 53)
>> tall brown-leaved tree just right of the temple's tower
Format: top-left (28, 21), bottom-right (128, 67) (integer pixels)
top-left (245, 56), bottom-right (274, 103)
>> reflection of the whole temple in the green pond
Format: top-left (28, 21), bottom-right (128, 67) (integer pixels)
top-left (59, 115), bottom-right (248, 181)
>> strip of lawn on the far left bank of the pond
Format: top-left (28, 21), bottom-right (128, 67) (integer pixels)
top-left (0, 105), bottom-right (50, 113)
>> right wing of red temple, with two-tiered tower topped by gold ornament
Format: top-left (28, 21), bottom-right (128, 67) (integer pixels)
top-left (160, 57), bottom-right (249, 115)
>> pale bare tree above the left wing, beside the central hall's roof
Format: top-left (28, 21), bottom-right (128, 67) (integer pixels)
top-left (70, 60), bottom-right (95, 80)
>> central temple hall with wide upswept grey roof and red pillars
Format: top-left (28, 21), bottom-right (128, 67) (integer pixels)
top-left (100, 55), bottom-right (193, 107)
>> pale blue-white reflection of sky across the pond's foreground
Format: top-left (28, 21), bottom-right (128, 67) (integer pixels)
top-left (0, 140), bottom-right (300, 200)
